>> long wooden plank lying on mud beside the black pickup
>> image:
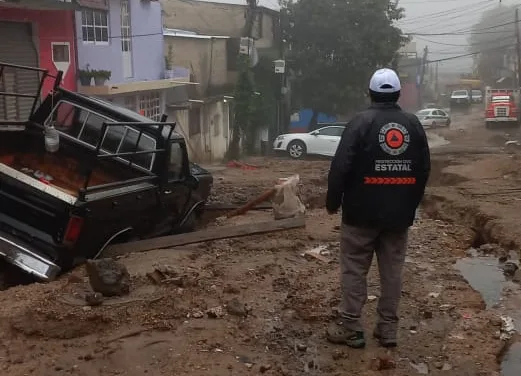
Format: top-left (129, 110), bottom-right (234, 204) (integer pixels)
top-left (105, 217), bottom-right (306, 257)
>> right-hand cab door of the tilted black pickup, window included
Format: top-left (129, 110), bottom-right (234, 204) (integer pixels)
top-left (161, 140), bottom-right (190, 223)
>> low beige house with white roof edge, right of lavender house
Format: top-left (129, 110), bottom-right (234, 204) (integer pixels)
top-left (164, 29), bottom-right (234, 163)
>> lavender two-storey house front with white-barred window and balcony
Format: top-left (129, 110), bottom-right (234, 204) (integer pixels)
top-left (75, 0), bottom-right (189, 121)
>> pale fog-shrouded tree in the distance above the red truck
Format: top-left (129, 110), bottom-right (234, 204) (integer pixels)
top-left (468, 6), bottom-right (518, 85)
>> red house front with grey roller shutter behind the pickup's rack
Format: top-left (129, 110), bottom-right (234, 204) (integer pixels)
top-left (0, 0), bottom-right (77, 120)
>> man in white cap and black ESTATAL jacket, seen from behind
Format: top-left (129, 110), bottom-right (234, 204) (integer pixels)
top-left (326, 69), bottom-right (430, 348)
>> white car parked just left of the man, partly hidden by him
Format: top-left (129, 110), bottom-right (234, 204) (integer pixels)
top-left (273, 125), bottom-right (345, 159)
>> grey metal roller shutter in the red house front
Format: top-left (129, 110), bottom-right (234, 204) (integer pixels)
top-left (0, 21), bottom-right (39, 120)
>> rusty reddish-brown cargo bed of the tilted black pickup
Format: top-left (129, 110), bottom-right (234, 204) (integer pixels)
top-left (0, 132), bottom-right (140, 198)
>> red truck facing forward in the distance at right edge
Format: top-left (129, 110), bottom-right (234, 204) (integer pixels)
top-left (485, 90), bottom-right (519, 128)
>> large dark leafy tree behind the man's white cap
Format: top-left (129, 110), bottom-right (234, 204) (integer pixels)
top-left (281, 0), bottom-right (405, 122)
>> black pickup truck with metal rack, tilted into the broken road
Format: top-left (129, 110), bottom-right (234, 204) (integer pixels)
top-left (0, 63), bottom-right (213, 281)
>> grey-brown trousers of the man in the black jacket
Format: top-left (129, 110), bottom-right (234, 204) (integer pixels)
top-left (340, 224), bottom-right (408, 338)
